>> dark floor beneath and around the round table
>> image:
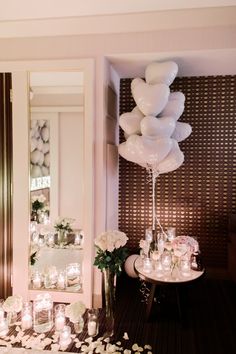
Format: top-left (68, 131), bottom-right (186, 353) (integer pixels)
top-left (115, 275), bottom-right (236, 354)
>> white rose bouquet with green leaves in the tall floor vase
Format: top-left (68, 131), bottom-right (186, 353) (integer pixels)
top-left (94, 230), bottom-right (128, 275)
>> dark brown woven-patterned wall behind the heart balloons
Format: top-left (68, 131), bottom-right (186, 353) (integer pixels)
top-left (119, 76), bottom-right (236, 267)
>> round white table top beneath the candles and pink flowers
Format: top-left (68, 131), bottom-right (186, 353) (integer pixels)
top-left (134, 256), bottom-right (205, 284)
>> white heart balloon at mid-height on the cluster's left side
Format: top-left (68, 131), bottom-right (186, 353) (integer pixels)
top-left (119, 107), bottom-right (144, 135)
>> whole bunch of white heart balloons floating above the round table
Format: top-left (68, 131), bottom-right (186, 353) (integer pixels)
top-left (119, 61), bottom-right (192, 174)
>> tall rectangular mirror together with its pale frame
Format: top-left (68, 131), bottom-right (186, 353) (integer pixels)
top-left (9, 59), bottom-right (94, 307)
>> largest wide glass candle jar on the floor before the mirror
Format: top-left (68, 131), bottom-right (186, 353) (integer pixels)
top-left (33, 293), bottom-right (53, 333)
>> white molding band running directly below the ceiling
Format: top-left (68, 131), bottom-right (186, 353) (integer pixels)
top-left (0, 6), bottom-right (235, 38)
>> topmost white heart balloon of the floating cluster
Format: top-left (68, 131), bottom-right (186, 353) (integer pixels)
top-left (145, 61), bottom-right (178, 86)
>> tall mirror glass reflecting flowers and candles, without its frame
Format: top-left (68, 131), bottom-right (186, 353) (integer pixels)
top-left (29, 72), bottom-right (84, 292)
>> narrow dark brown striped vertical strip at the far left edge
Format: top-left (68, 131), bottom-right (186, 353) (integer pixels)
top-left (0, 73), bottom-right (12, 298)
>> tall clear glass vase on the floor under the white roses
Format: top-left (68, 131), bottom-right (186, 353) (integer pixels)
top-left (104, 268), bottom-right (116, 337)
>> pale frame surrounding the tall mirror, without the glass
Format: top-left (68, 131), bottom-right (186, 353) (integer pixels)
top-left (0, 59), bottom-right (95, 307)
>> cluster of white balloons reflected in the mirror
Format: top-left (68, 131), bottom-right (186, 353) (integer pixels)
top-left (30, 119), bottom-right (50, 178)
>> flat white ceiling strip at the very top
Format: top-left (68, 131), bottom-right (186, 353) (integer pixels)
top-left (0, 0), bottom-right (236, 21)
